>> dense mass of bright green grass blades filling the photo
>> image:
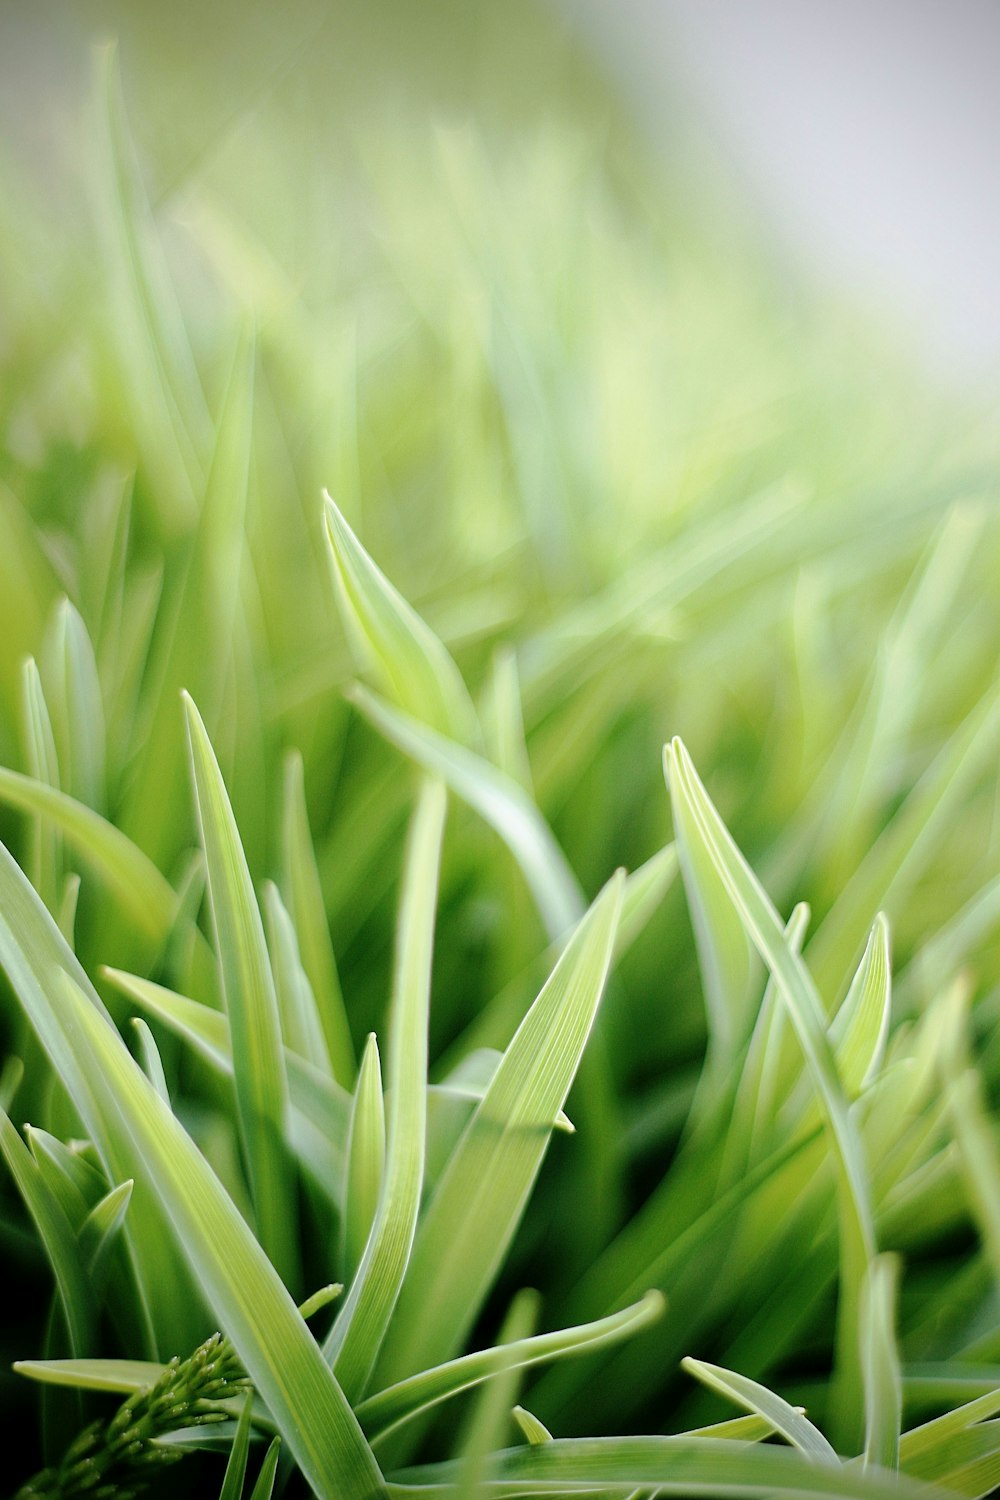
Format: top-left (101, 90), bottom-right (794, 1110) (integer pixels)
top-left (0, 8), bottom-right (1000, 1500)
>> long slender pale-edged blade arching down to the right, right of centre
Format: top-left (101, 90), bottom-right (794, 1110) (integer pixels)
top-left (664, 740), bottom-right (876, 1446)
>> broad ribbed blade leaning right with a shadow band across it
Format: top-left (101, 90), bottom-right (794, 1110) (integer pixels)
top-left (378, 872), bottom-right (624, 1386)
